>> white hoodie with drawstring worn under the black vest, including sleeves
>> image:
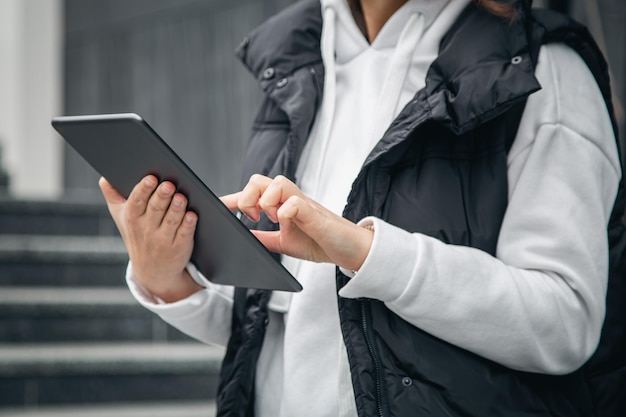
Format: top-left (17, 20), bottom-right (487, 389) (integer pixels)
top-left (127, 0), bottom-right (620, 417)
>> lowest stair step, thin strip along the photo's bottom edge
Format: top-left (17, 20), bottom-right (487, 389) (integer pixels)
top-left (0, 401), bottom-right (215, 417)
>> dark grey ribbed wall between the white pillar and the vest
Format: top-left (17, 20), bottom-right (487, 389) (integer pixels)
top-left (64, 0), bottom-right (291, 196)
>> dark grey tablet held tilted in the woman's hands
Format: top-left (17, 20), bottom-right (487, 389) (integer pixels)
top-left (52, 113), bottom-right (302, 291)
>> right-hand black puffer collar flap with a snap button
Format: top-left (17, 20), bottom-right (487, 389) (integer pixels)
top-left (425, 3), bottom-right (541, 134)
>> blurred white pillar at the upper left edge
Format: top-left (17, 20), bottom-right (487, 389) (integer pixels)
top-left (0, 0), bottom-right (63, 198)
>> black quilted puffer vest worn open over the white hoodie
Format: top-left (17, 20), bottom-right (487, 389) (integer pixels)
top-left (218, 0), bottom-right (626, 417)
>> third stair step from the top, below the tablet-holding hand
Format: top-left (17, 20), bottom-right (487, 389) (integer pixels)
top-left (0, 287), bottom-right (189, 343)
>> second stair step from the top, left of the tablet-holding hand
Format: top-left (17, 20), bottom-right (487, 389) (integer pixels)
top-left (0, 235), bottom-right (128, 286)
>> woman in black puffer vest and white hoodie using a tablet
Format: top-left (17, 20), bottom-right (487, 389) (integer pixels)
top-left (101, 0), bottom-right (623, 416)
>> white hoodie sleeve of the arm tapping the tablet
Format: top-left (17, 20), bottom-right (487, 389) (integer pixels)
top-left (340, 44), bottom-right (621, 374)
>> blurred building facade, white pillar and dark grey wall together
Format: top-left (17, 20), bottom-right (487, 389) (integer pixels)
top-left (0, 0), bottom-right (291, 198)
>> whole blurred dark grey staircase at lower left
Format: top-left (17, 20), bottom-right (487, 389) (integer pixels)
top-left (0, 199), bottom-right (223, 417)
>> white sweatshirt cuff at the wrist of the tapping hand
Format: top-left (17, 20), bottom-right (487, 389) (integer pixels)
top-left (339, 217), bottom-right (418, 302)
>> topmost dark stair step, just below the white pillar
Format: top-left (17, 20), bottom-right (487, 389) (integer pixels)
top-left (0, 197), bottom-right (118, 235)
